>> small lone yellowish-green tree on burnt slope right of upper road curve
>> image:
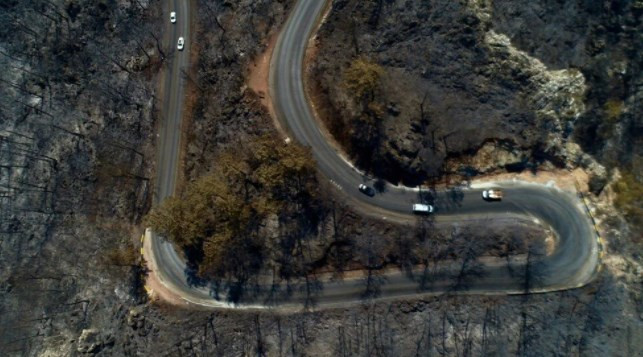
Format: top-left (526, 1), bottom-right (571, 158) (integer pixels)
top-left (344, 57), bottom-right (384, 101)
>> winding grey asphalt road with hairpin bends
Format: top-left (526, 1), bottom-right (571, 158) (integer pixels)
top-left (151, 0), bottom-right (598, 308)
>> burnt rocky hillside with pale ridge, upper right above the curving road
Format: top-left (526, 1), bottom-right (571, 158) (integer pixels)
top-left (309, 0), bottom-right (642, 191)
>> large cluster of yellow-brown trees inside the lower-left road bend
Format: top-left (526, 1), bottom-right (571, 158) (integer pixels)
top-left (146, 136), bottom-right (323, 282)
